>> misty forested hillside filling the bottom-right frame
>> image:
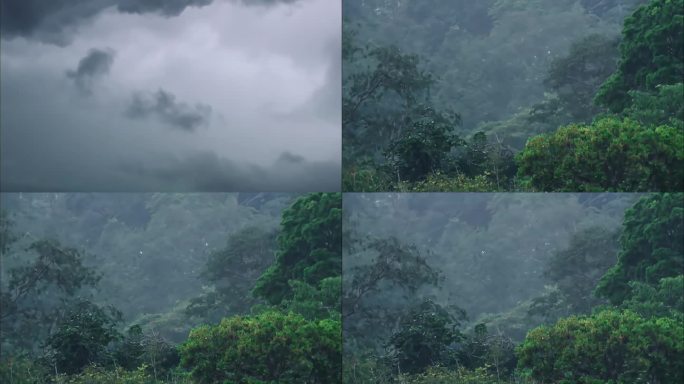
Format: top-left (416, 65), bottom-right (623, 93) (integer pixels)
top-left (342, 193), bottom-right (684, 384)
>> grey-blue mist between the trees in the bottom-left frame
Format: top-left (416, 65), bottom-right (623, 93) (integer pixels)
top-left (2, 193), bottom-right (296, 341)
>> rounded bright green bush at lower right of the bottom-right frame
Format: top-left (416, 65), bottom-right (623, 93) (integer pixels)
top-left (518, 310), bottom-right (684, 384)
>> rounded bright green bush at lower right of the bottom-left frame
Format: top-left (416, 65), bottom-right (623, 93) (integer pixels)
top-left (181, 311), bottom-right (342, 384)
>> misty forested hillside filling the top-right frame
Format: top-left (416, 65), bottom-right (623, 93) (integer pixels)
top-left (342, 0), bottom-right (684, 192)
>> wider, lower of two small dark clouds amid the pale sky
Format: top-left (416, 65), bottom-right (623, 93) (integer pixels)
top-left (126, 89), bottom-right (211, 132)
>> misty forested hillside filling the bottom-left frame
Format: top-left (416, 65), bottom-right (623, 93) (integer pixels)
top-left (0, 193), bottom-right (341, 384)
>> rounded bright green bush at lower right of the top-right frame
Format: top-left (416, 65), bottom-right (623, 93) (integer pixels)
top-left (516, 118), bottom-right (684, 192)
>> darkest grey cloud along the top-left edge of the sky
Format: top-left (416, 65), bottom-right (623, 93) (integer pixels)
top-left (0, 0), bottom-right (212, 46)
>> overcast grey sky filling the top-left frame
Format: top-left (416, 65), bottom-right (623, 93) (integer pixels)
top-left (0, 0), bottom-right (341, 192)
